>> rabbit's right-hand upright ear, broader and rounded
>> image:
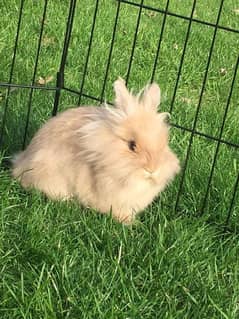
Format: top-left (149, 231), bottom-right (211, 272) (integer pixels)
top-left (141, 83), bottom-right (161, 112)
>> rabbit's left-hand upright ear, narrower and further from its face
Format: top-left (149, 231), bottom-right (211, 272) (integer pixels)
top-left (114, 77), bottom-right (135, 114)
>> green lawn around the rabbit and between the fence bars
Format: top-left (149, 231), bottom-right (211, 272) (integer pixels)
top-left (0, 0), bottom-right (239, 319)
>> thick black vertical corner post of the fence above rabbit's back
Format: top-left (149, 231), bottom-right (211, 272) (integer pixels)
top-left (52, 0), bottom-right (76, 116)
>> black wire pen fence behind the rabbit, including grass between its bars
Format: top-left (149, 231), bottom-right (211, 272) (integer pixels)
top-left (0, 0), bottom-right (239, 229)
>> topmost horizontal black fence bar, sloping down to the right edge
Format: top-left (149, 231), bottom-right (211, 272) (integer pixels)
top-left (116, 0), bottom-right (239, 33)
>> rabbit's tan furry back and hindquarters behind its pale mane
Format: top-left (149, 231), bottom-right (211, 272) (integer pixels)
top-left (12, 107), bottom-right (95, 199)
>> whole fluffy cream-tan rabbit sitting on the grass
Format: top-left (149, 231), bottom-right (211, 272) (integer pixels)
top-left (12, 78), bottom-right (180, 224)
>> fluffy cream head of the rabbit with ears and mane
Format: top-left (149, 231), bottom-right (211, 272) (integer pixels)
top-left (77, 78), bottom-right (179, 188)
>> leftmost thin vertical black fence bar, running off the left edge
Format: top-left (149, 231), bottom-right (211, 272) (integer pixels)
top-left (0, 0), bottom-right (24, 148)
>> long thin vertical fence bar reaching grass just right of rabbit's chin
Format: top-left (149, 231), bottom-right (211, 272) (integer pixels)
top-left (175, 0), bottom-right (224, 215)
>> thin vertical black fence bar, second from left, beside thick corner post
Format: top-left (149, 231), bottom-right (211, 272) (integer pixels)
top-left (22, 0), bottom-right (48, 149)
